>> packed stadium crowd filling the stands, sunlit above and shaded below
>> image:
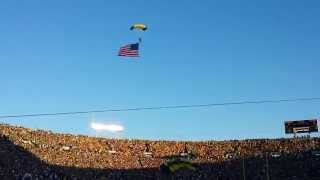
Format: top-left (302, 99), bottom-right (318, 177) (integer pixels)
top-left (0, 124), bottom-right (320, 180)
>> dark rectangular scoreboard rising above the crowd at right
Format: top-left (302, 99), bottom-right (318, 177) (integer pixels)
top-left (284, 119), bottom-right (318, 134)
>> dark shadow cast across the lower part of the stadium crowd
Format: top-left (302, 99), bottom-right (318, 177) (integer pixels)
top-left (0, 135), bottom-right (320, 180)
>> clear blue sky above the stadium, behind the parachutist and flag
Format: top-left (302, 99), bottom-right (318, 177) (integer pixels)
top-left (0, 0), bottom-right (320, 140)
